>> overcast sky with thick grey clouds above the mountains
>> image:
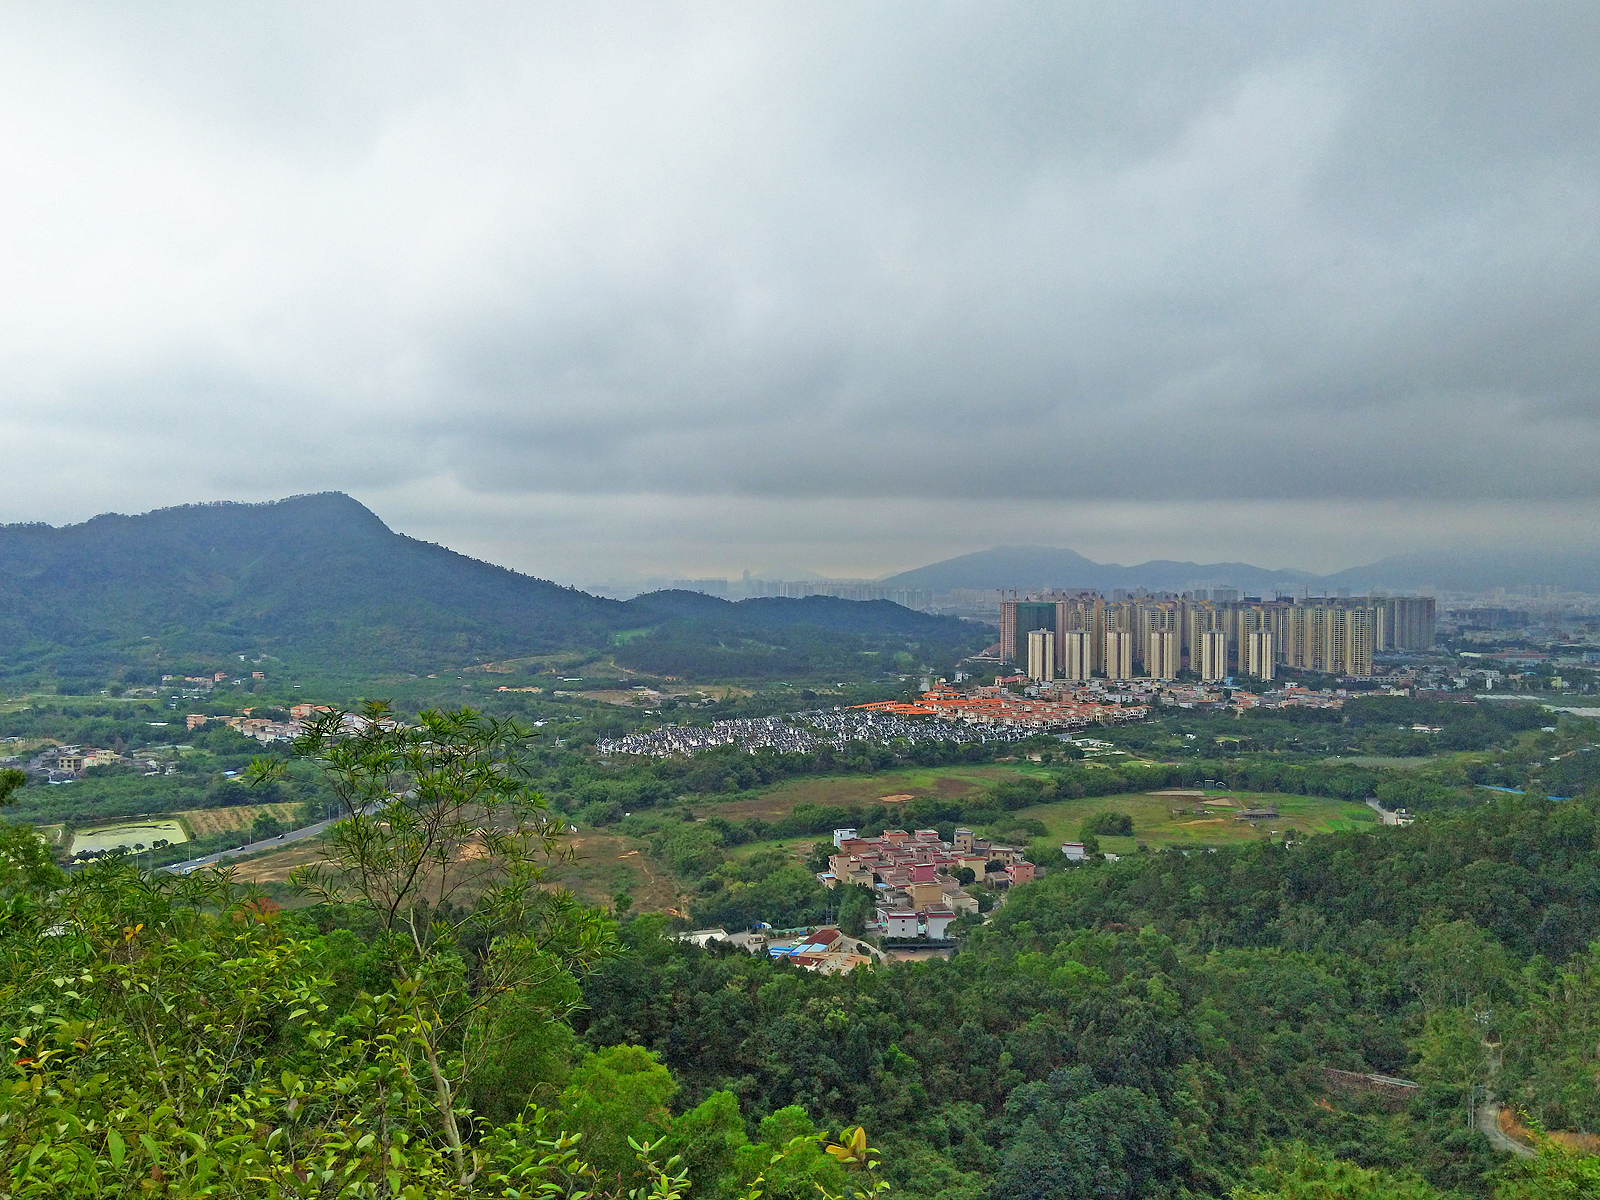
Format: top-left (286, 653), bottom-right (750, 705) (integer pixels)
top-left (0, 0), bottom-right (1600, 582)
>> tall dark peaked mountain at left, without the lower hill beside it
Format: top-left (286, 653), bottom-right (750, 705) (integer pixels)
top-left (0, 493), bottom-right (624, 675)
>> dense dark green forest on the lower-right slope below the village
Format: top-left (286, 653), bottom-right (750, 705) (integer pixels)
top-left (576, 797), bottom-right (1600, 1200)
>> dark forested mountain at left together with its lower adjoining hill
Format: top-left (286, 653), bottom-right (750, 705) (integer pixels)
top-left (0, 493), bottom-right (981, 686)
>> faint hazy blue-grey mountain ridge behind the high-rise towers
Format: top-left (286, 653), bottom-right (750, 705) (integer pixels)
top-left (880, 546), bottom-right (1600, 597)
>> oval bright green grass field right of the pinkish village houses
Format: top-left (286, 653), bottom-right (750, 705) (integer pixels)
top-left (1018, 790), bottom-right (1381, 854)
